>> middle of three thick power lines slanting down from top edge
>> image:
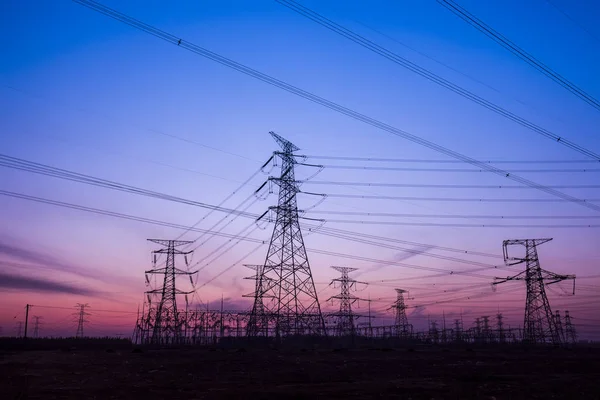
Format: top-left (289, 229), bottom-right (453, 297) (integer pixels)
top-left (275, 0), bottom-right (600, 161)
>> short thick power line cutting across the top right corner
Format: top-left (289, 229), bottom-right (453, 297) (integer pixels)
top-left (437, 0), bottom-right (600, 111)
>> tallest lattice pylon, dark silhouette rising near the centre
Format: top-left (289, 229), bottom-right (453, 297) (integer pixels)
top-left (247, 132), bottom-right (326, 338)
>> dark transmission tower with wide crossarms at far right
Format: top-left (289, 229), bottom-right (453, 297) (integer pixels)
top-left (493, 239), bottom-right (575, 344)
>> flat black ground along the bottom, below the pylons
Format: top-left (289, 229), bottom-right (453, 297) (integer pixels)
top-left (0, 347), bottom-right (600, 400)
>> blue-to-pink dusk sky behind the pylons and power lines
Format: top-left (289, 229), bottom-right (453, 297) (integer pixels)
top-left (0, 0), bottom-right (600, 339)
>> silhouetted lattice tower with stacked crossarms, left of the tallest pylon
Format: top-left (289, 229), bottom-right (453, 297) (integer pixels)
top-left (146, 239), bottom-right (197, 344)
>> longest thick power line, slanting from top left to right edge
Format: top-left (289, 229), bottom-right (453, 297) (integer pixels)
top-left (73, 0), bottom-right (600, 211)
